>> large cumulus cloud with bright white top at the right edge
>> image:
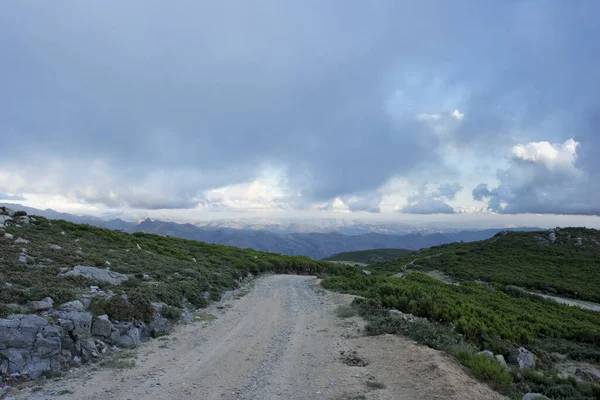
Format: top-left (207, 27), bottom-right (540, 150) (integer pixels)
top-left (472, 139), bottom-right (600, 215)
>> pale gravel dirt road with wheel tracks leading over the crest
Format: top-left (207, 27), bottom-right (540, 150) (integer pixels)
top-left (14, 275), bottom-right (502, 400)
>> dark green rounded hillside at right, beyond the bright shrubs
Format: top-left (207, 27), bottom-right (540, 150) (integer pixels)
top-left (373, 228), bottom-right (600, 302)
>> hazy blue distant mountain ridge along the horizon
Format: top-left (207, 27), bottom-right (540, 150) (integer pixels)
top-left (0, 204), bottom-right (541, 259)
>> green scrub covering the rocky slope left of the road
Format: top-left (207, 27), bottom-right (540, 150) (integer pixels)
top-left (0, 217), bottom-right (347, 321)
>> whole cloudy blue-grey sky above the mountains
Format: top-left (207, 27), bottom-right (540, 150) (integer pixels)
top-left (0, 0), bottom-right (600, 225)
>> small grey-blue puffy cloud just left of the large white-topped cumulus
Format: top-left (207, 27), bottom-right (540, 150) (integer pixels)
top-left (401, 183), bottom-right (462, 214)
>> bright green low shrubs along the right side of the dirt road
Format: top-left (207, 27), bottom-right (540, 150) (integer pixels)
top-left (322, 244), bottom-right (600, 399)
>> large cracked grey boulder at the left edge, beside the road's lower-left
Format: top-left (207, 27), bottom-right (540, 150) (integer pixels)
top-left (0, 314), bottom-right (63, 378)
